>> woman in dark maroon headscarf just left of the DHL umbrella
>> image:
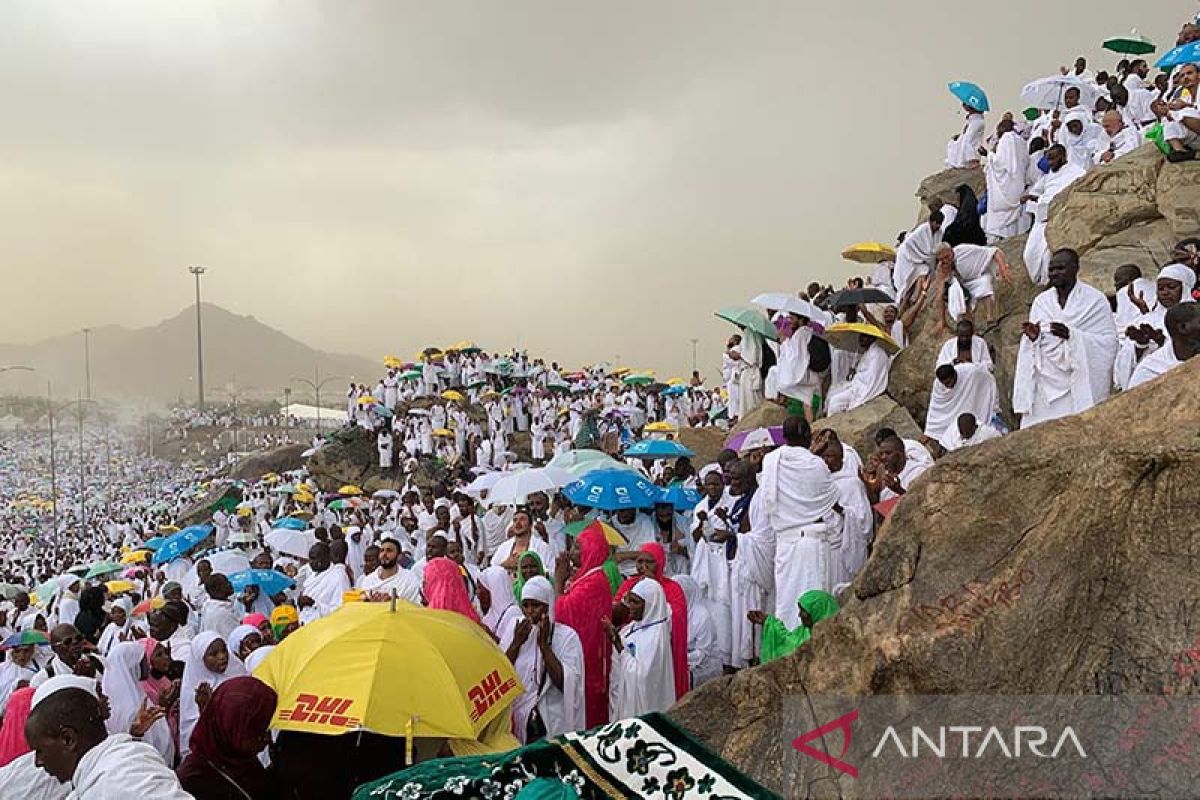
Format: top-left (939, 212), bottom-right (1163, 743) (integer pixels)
top-left (176, 675), bottom-right (282, 800)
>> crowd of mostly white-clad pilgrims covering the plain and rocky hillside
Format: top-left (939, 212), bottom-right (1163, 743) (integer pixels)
top-left (0, 14), bottom-right (1200, 800)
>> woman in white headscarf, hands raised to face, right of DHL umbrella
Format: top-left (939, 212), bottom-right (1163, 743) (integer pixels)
top-left (500, 576), bottom-right (587, 744)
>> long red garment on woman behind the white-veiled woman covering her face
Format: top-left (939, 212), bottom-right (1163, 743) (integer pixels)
top-left (554, 525), bottom-right (612, 728)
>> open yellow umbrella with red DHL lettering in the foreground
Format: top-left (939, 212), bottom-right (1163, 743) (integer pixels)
top-left (254, 601), bottom-right (524, 739)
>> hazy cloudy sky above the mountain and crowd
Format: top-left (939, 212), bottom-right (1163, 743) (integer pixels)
top-left (0, 0), bottom-right (1180, 373)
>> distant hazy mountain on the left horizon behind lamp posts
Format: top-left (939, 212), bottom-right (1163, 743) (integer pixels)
top-left (0, 303), bottom-right (382, 404)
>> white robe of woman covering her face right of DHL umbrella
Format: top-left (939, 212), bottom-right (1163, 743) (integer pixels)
top-left (500, 614), bottom-right (587, 745)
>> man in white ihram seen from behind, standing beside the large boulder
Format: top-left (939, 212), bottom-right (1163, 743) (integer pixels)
top-left (760, 416), bottom-right (841, 627)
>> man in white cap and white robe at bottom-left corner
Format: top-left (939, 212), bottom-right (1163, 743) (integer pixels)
top-left (25, 678), bottom-right (192, 800)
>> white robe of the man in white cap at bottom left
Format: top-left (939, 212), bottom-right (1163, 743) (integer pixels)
top-left (71, 733), bottom-right (194, 800)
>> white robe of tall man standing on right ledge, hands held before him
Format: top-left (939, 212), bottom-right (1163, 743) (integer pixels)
top-left (1013, 282), bottom-right (1117, 428)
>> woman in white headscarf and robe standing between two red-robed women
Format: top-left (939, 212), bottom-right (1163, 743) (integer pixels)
top-left (605, 578), bottom-right (676, 721)
